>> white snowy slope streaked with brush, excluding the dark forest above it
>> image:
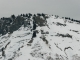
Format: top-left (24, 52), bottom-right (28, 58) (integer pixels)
top-left (0, 16), bottom-right (80, 60)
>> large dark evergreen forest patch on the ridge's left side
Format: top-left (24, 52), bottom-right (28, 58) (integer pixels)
top-left (0, 13), bottom-right (32, 35)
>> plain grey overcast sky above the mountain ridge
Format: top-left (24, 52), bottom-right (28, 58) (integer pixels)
top-left (0, 0), bottom-right (80, 20)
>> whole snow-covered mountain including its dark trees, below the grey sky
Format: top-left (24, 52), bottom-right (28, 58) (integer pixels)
top-left (0, 13), bottom-right (80, 60)
